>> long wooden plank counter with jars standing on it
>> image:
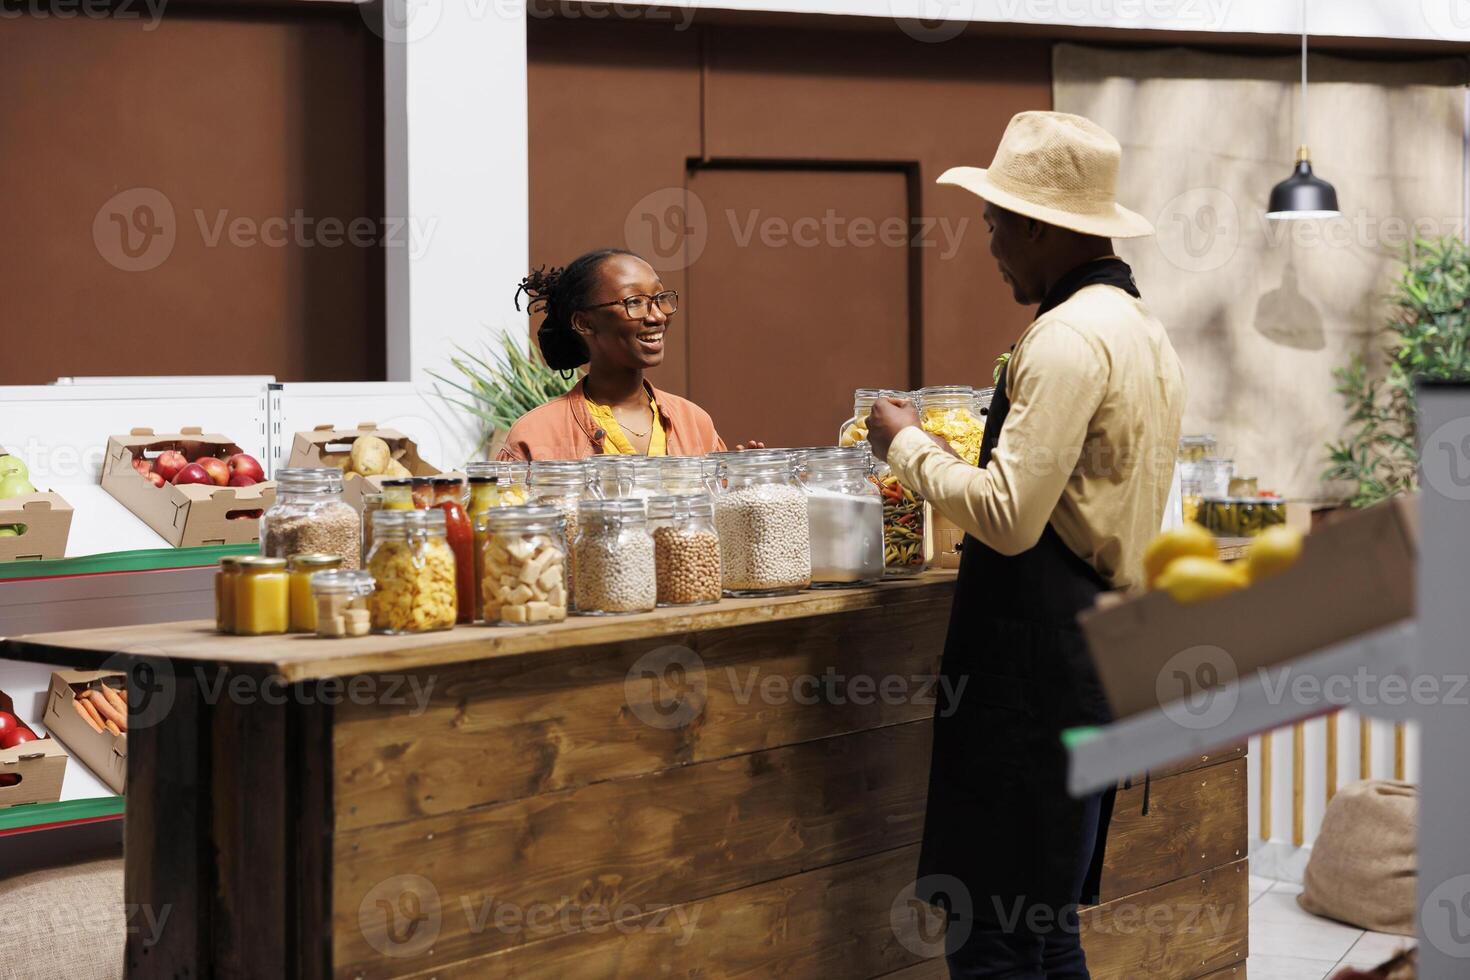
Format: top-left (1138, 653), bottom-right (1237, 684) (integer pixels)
top-left (3, 572), bottom-right (1247, 980)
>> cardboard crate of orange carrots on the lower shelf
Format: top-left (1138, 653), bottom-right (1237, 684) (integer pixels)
top-left (43, 670), bottom-right (128, 793)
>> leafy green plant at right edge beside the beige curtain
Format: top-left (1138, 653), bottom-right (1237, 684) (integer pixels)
top-left (1323, 235), bottom-right (1470, 507)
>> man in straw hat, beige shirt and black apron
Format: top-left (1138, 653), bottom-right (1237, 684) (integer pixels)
top-left (867, 112), bottom-right (1185, 980)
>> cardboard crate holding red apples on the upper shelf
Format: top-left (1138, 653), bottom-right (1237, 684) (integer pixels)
top-left (101, 428), bottom-right (275, 548)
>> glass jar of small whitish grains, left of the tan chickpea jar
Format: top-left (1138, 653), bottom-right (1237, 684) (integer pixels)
top-left (573, 498), bottom-right (659, 616)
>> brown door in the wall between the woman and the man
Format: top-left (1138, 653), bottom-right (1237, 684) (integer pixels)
top-left (681, 167), bottom-right (913, 447)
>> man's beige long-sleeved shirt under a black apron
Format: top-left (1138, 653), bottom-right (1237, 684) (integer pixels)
top-left (888, 284), bottom-right (1185, 589)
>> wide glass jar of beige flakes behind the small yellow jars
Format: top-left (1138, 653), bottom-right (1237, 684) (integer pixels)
top-left (260, 467), bottom-right (363, 569)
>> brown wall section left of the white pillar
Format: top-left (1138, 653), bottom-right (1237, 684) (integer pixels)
top-left (0, 3), bottom-right (385, 383)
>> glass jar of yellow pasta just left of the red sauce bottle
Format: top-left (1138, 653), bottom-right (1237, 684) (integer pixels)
top-left (368, 510), bottom-right (457, 633)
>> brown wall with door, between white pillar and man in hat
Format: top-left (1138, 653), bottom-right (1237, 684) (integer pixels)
top-left (529, 21), bottom-right (1051, 445)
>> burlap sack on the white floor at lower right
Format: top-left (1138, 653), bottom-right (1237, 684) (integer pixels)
top-left (1297, 779), bottom-right (1419, 936)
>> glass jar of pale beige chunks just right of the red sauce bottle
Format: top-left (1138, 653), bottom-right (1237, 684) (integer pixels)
top-left (475, 504), bottom-right (572, 626)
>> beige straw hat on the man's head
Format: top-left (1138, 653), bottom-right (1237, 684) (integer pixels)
top-left (938, 112), bottom-right (1154, 238)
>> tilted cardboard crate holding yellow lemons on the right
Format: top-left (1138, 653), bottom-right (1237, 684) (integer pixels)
top-left (1080, 498), bottom-right (1419, 718)
